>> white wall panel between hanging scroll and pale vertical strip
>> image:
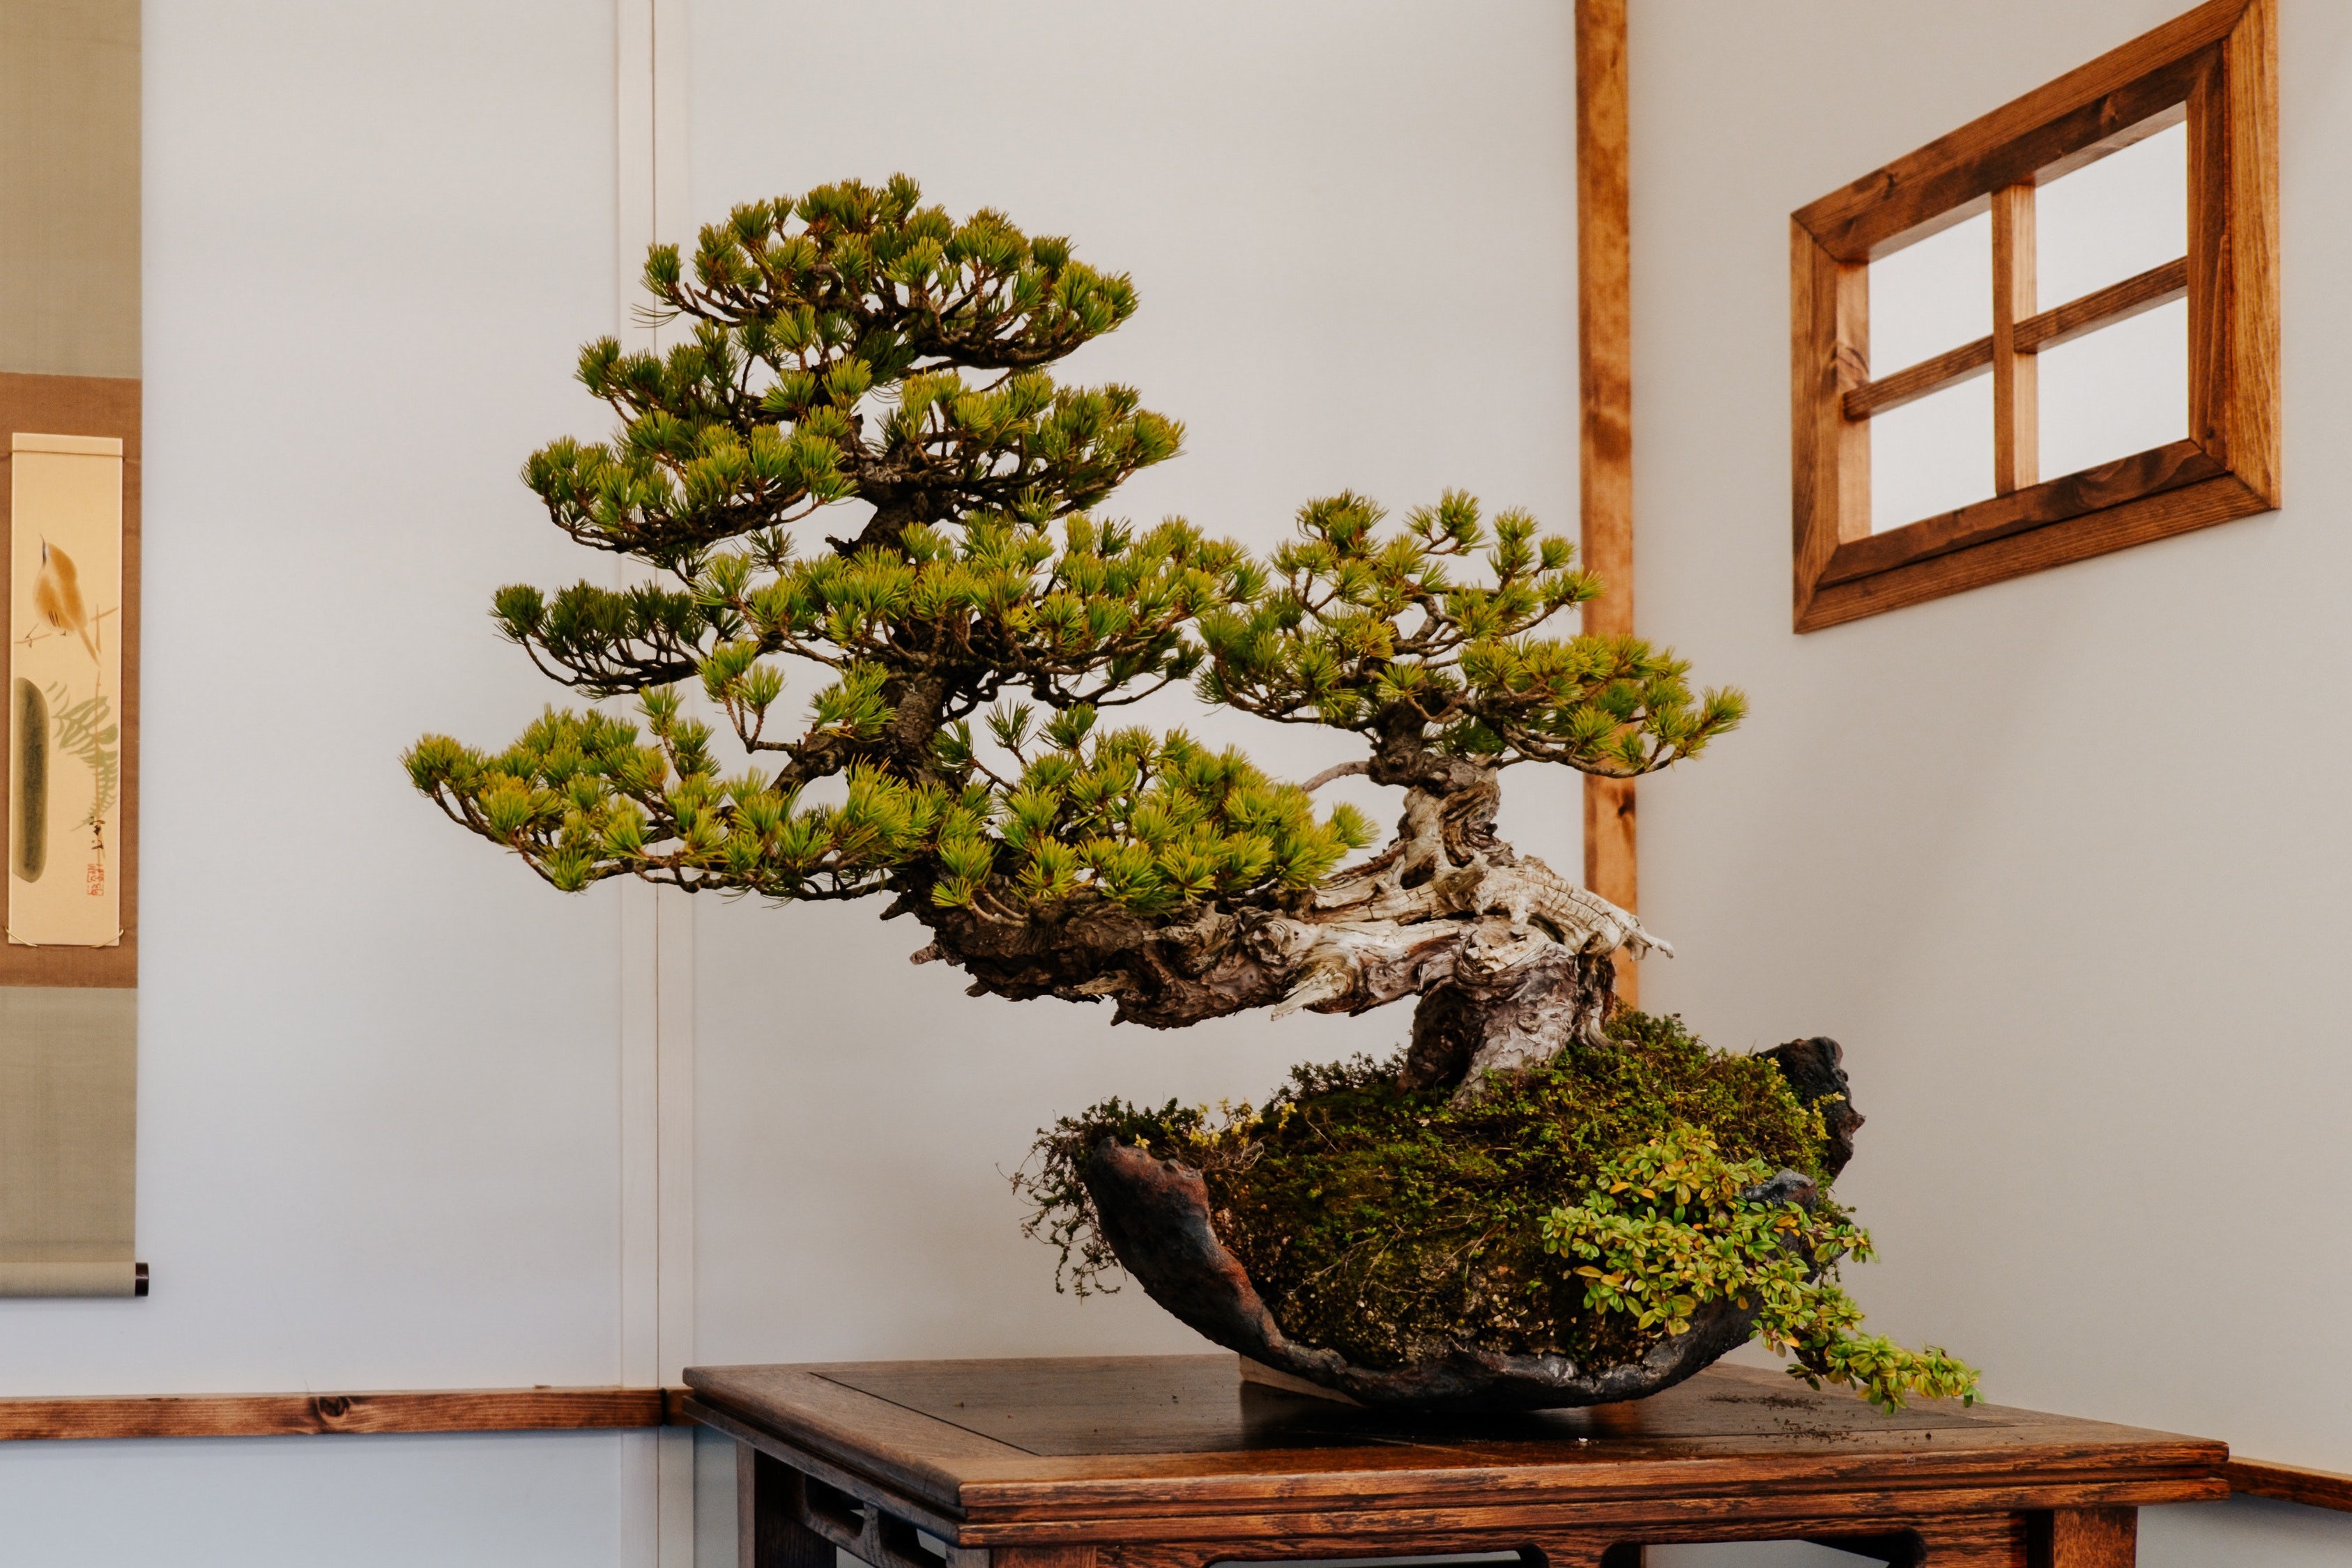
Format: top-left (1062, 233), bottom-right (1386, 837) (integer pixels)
top-left (0, 0), bottom-right (644, 1566)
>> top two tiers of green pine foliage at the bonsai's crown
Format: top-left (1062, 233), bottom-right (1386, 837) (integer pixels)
top-left (524, 174), bottom-right (1183, 567)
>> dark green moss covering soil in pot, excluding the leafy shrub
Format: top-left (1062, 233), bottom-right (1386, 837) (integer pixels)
top-left (1018, 1011), bottom-right (1825, 1368)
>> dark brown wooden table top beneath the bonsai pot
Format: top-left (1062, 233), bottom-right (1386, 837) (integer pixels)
top-left (687, 1354), bottom-right (2230, 1540)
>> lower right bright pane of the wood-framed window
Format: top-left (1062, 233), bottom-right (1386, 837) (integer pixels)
top-left (2039, 298), bottom-right (2190, 479)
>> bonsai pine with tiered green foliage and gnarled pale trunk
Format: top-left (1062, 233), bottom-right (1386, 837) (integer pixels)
top-left (407, 176), bottom-right (1976, 1420)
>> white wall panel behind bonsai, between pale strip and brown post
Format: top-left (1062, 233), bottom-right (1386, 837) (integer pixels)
top-left (692, 0), bottom-right (1580, 1364)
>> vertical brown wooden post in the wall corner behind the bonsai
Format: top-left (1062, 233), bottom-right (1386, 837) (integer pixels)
top-left (1576, 0), bottom-right (1642, 1006)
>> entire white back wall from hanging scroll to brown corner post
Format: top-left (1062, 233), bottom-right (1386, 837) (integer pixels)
top-left (0, 0), bottom-right (1578, 1566)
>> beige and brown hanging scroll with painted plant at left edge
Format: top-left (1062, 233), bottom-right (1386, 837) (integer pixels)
top-left (0, 0), bottom-right (146, 1298)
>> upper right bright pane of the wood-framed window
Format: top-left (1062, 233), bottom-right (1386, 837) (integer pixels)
top-left (2041, 125), bottom-right (2190, 310)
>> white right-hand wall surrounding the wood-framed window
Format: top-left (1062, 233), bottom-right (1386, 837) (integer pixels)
top-left (1633, 0), bottom-right (2352, 1568)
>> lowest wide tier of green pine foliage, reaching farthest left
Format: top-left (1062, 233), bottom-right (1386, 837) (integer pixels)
top-left (409, 679), bottom-right (1373, 914)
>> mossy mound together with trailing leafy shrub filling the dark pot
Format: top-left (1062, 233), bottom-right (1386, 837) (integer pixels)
top-left (1014, 1011), bottom-right (1973, 1408)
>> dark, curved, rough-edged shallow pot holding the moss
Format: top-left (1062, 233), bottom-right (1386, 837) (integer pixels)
top-left (1084, 1039), bottom-right (1863, 1411)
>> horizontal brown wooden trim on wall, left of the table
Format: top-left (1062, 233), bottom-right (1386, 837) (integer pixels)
top-left (0, 1387), bottom-right (687, 1443)
